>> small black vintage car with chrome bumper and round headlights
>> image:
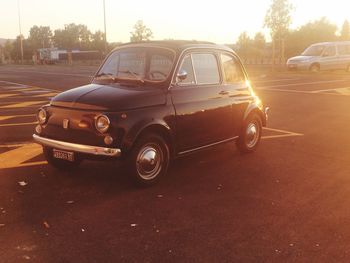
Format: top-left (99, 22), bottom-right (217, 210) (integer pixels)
top-left (33, 41), bottom-right (267, 185)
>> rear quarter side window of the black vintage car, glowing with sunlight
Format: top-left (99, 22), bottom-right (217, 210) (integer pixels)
top-left (221, 54), bottom-right (245, 84)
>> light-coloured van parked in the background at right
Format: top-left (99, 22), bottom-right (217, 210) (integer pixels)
top-left (287, 41), bottom-right (350, 72)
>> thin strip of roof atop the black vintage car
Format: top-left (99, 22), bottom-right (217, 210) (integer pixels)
top-left (116, 40), bottom-right (233, 52)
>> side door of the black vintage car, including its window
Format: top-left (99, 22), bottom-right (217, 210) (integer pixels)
top-left (170, 51), bottom-right (233, 152)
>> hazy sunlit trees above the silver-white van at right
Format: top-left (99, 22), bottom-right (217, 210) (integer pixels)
top-left (238, 0), bottom-right (350, 64)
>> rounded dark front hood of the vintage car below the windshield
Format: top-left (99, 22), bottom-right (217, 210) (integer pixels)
top-left (51, 84), bottom-right (166, 111)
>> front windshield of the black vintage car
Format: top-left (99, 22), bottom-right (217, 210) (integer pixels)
top-left (95, 47), bottom-right (175, 83)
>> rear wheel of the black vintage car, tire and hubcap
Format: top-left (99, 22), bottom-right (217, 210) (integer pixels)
top-left (237, 113), bottom-right (262, 153)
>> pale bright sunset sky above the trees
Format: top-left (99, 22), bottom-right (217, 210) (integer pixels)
top-left (0, 0), bottom-right (350, 44)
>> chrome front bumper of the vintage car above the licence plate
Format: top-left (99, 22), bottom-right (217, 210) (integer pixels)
top-left (33, 134), bottom-right (121, 157)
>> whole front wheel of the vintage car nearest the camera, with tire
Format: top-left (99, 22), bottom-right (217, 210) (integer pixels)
top-left (126, 133), bottom-right (170, 186)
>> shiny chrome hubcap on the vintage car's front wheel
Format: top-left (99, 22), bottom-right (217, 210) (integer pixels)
top-left (136, 144), bottom-right (163, 180)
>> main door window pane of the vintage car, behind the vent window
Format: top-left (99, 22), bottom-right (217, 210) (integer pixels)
top-left (192, 53), bottom-right (220, 85)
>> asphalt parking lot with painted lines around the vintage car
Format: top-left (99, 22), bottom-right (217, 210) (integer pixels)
top-left (0, 66), bottom-right (350, 262)
